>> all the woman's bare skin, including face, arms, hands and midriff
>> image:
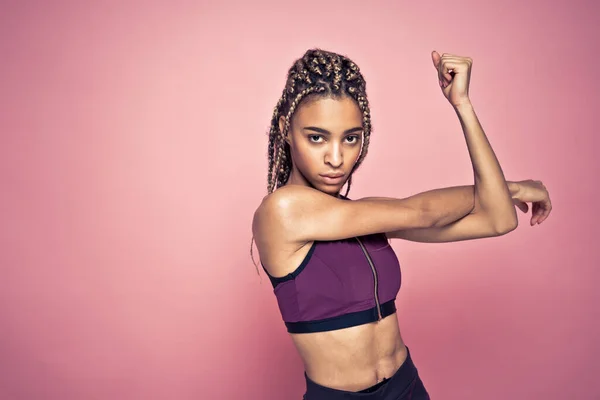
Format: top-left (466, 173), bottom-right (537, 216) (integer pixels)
top-left (252, 51), bottom-right (552, 391)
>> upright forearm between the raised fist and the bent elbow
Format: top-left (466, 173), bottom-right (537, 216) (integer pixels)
top-left (455, 103), bottom-right (517, 230)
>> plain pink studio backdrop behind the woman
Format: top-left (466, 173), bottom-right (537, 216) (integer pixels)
top-left (0, 0), bottom-right (600, 400)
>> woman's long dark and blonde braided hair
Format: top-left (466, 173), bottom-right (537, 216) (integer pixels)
top-left (250, 48), bottom-right (371, 272)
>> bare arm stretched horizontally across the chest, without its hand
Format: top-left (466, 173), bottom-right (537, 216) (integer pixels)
top-left (253, 185), bottom-right (472, 243)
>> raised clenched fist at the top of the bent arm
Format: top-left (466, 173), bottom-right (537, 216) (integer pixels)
top-left (431, 50), bottom-right (473, 107)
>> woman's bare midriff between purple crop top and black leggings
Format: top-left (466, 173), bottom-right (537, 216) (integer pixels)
top-left (291, 313), bottom-right (407, 392)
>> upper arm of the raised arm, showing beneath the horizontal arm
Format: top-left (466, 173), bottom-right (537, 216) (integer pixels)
top-left (387, 212), bottom-right (506, 243)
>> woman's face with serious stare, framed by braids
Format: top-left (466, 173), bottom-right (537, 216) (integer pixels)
top-left (279, 97), bottom-right (363, 195)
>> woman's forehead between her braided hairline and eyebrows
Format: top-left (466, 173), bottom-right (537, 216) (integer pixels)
top-left (293, 96), bottom-right (362, 131)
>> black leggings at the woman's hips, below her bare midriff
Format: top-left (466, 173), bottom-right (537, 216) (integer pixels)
top-left (303, 347), bottom-right (429, 400)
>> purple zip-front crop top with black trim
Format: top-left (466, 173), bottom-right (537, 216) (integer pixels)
top-left (263, 233), bottom-right (401, 333)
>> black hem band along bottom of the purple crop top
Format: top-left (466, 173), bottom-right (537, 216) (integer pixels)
top-left (285, 299), bottom-right (396, 333)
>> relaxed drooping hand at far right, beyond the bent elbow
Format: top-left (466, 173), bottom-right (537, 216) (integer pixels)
top-left (510, 179), bottom-right (552, 226)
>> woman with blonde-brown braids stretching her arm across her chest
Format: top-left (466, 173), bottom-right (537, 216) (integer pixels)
top-left (252, 49), bottom-right (551, 400)
